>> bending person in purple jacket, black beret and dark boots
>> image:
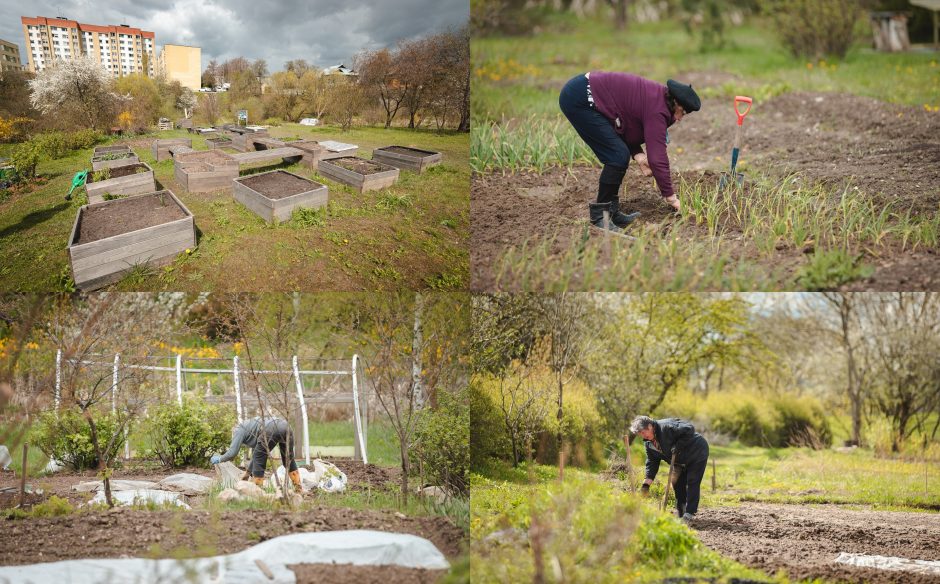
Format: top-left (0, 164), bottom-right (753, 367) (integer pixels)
top-left (558, 71), bottom-right (702, 231)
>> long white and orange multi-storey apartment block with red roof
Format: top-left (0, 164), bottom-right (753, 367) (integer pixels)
top-left (20, 16), bottom-right (154, 77)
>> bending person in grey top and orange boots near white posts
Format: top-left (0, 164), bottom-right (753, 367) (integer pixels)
top-left (209, 418), bottom-right (301, 492)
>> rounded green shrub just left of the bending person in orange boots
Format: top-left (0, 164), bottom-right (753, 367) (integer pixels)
top-left (150, 397), bottom-right (235, 466)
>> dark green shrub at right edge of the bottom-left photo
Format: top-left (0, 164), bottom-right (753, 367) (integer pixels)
top-left (413, 388), bottom-right (470, 495)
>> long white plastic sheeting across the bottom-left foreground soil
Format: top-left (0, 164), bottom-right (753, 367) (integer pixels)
top-left (0, 530), bottom-right (450, 584)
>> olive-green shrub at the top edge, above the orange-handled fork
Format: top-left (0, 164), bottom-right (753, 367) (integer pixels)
top-left (765, 0), bottom-right (861, 59)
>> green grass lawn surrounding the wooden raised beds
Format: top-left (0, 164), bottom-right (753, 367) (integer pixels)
top-left (0, 124), bottom-right (470, 291)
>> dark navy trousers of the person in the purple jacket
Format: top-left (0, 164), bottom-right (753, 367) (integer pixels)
top-left (558, 74), bottom-right (630, 170)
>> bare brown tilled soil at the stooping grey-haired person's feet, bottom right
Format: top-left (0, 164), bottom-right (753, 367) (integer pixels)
top-left (695, 503), bottom-right (940, 584)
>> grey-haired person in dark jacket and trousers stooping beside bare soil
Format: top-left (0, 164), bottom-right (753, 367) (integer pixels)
top-left (630, 416), bottom-right (708, 524)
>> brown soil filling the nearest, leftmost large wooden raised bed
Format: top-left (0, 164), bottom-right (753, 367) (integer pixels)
top-left (74, 194), bottom-right (186, 244)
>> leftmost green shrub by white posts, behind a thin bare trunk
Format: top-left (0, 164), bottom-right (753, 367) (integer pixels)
top-left (31, 409), bottom-right (124, 471)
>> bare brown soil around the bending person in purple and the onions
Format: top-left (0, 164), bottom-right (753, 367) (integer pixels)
top-left (470, 93), bottom-right (940, 291)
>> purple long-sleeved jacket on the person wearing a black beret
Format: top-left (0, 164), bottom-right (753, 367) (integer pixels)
top-left (590, 71), bottom-right (675, 197)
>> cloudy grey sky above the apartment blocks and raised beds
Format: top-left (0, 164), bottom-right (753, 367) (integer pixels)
top-left (0, 0), bottom-right (470, 72)
